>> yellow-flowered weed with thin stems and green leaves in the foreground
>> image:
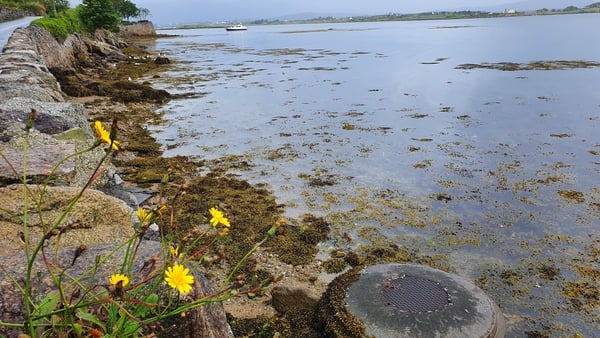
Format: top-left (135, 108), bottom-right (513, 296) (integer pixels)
top-left (0, 110), bottom-right (284, 338)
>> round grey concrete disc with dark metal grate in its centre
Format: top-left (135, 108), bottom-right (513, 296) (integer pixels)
top-left (346, 264), bottom-right (504, 338)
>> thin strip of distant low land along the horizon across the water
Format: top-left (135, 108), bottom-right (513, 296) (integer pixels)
top-left (157, 2), bottom-right (600, 30)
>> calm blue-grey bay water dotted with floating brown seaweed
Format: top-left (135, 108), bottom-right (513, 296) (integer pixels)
top-left (140, 14), bottom-right (600, 337)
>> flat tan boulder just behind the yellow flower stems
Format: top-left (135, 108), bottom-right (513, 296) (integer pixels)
top-left (0, 184), bottom-right (134, 256)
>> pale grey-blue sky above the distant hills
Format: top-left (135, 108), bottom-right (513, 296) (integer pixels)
top-left (71, 0), bottom-right (597, 26)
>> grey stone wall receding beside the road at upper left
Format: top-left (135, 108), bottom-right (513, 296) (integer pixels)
top-left (0, 26), bottom-right (109, 186)
